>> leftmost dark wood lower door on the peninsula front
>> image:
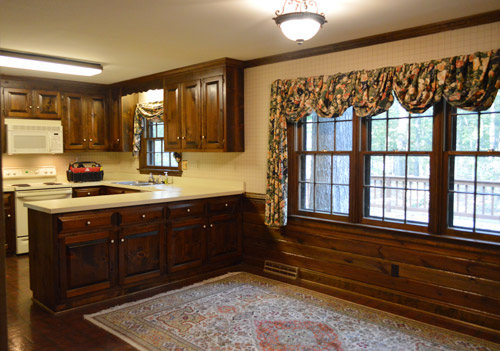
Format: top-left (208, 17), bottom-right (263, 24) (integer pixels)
top-left (59, 231), bottom-right (116, 298)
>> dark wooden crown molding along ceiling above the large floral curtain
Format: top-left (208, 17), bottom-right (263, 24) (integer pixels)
top-left (245, 10), bottom-right (500, 68)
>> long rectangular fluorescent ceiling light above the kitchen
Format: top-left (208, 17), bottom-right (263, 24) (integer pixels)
top-left (0, 50), bottom-right (102, 76)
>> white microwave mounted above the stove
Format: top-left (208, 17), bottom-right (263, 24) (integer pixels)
top-left (5, 118), bottom-right (63, 155)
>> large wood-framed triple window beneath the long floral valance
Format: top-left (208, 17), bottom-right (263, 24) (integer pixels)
top-left (288, 94), bottom-right (500, 241)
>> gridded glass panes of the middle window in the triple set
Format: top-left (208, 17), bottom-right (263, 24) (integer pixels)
top-left (363, 102), bottom-right (434, 225)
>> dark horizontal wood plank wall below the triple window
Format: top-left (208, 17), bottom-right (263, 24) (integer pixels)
top-left (243, 194), bottom-right (500, 343)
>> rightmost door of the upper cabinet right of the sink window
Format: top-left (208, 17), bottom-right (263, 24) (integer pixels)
top-left (201, 76), bottom-right (225, 150)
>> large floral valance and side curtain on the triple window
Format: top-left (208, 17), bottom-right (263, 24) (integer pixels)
top-left (266, 49), bottom-right (500, 227)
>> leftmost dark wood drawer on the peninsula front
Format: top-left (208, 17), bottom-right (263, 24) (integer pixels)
top-left (57, 211), bottom-right (113, 233)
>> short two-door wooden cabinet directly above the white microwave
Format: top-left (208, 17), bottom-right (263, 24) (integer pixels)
top-left (3, 88), bottom-right (61, 119)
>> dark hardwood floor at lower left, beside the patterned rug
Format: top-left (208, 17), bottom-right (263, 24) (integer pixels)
top-left (6, 255), bottom-right (135, 351)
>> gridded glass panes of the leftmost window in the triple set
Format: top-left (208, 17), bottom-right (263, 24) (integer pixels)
top-left (297, 108), bottom-right (353, 217)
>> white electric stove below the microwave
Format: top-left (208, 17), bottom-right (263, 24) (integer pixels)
top-left (2, 166), bottom-right (71, 255)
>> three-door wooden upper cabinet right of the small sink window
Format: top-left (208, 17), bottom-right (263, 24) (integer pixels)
top-left (163, 60), bottom-right (244, 152)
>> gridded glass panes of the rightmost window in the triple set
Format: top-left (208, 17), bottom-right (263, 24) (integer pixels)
top-left (448, 94), bottom-right (500, 235)
